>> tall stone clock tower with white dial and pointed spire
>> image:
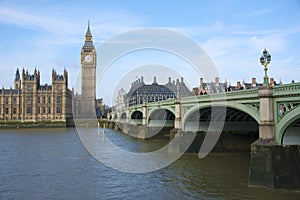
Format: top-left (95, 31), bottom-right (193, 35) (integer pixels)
top-left (81, 22), bottom-right (97, 118)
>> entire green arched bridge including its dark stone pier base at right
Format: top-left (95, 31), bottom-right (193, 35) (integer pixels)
top-left (108, 83), bottom-right (300, 188)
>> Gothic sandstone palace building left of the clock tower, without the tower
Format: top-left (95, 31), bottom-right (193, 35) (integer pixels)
top-left (0, 69), bottom-right (73, 122)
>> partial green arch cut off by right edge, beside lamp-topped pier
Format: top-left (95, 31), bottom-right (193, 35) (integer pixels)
top-left (275, 106), bottom-right (300, 144)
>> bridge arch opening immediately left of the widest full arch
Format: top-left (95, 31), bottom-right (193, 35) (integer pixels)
top-left (148, 108), bottom-right (175, 127)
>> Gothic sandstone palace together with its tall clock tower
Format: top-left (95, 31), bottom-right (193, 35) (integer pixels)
top-left (0, 21), bottom-right (99, 122)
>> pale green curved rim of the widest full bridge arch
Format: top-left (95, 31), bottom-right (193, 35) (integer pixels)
top-left (182, 102), bottom-right (260, 131)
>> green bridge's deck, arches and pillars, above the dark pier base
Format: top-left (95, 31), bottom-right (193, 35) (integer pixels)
top-left (108, 83), bottom-right (300, 145)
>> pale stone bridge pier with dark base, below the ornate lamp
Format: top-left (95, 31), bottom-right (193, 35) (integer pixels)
top-left (248, 86), bottom-right (300, 188)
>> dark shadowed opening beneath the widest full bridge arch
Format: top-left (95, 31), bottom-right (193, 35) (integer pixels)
top-left (182, 103), bottom-right (259, 152)
